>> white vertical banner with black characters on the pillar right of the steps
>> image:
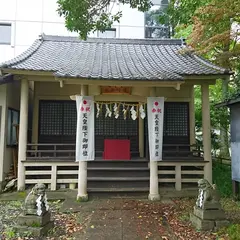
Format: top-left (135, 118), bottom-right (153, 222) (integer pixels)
top-left (147, 97), bottom-right (164, 161)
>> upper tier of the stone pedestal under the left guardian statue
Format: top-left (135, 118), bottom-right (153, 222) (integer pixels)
top-left (18, 212), bottom-right (51, 227)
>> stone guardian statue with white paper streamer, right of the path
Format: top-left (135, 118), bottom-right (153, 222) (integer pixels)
top-left (196, 179), bottom-right (220, 209)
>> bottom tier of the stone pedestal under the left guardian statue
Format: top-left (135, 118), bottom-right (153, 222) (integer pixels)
top-left (15, 222), bottom-right (54, 237)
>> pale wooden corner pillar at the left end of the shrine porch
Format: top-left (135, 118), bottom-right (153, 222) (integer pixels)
top-left (18, 79), bottom-right (29, 191)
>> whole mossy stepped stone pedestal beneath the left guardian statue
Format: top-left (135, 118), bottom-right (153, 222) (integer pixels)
top-left (15, 212), bottom-right (54, 237)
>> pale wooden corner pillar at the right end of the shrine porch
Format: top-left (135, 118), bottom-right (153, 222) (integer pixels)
top-left (201, 84), bottom-right (212, 183)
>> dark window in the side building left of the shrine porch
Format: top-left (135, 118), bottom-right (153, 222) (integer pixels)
top-left (7, 108), bottom-right (19, 146)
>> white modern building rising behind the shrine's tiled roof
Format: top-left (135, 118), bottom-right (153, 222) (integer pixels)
top-left (0, 0), bottom-right (168, 62)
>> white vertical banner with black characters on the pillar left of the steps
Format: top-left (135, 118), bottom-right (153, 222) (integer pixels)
top-left (76, 96), bottom-right (95, 161)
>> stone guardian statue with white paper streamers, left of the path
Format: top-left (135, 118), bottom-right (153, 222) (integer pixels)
top-left (24, 183), bottom-right (49, 216)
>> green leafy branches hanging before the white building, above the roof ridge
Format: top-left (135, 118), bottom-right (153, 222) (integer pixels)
top-left (57, 0), bottom-right (151, 39)
